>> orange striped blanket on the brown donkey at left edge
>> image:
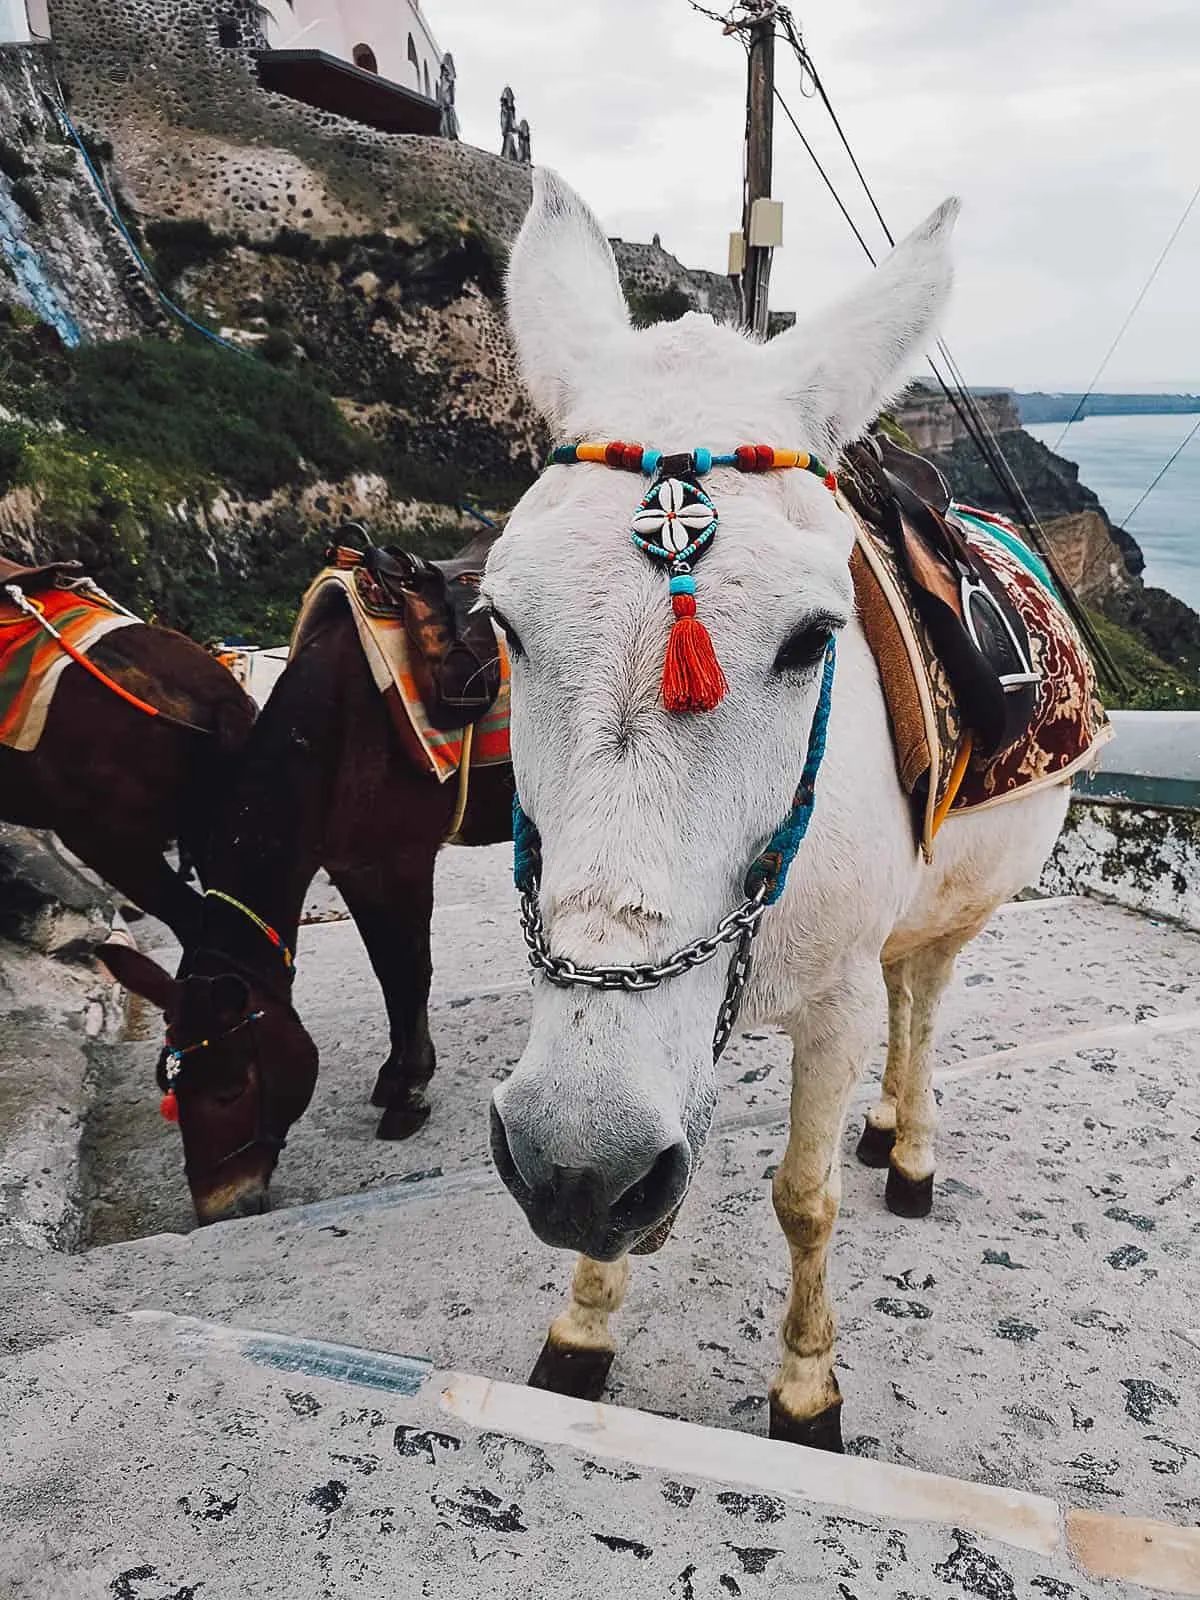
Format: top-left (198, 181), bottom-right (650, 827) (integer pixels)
top-left (0, 579), bottom-right (138, 750)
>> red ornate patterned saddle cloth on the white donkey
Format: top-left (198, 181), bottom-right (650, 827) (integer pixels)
top-left (843, 501), bottom-right (1112, 859)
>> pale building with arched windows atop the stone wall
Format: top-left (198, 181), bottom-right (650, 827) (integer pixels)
top-left (265, 0), bottom-right (442, 99)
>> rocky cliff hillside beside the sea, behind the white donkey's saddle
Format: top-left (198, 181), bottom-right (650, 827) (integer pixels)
top-left (894, 384), bottom-right (1200, 709)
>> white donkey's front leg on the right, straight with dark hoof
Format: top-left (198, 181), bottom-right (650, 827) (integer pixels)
top-left (770, 1008), bottom-right (870, 1451)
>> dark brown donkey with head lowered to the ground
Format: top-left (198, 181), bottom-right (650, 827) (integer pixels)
top-left (101, 588), bottom-right (512, 1222)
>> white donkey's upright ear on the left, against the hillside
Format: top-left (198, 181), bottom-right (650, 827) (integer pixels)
top-left (509, 166), bottom-right (630, 424)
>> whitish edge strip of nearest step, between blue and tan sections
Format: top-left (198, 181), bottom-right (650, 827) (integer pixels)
top-left (442, 1373), bottom-right (1062, 1555)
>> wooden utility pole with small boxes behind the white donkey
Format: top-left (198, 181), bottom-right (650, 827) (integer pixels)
top-left (725, 0), bottom-right (782, 338)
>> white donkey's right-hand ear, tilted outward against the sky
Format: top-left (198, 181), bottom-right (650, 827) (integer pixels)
top-left (766, 198), bottom-right (958, 456)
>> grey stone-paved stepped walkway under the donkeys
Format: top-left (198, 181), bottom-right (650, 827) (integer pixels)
top-left (0, 851), bottom-right (1200, 1600)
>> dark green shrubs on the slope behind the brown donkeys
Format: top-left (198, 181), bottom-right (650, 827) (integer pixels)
top-left (0, 284), bottom-right (528, 643)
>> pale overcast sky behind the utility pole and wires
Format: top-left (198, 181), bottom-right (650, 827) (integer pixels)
top-left (441, 0), bottom-right (1200, 390)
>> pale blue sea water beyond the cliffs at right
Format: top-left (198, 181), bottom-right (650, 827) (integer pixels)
top-left (1026, 414), bottom-right (1200, 611)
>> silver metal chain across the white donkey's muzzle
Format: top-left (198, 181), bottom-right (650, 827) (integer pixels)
top-left (522, 883), bottom-right (766, 1061)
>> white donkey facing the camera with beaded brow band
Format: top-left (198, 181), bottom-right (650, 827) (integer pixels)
top-left (483, 171), bottom-right (1067, 1450)
